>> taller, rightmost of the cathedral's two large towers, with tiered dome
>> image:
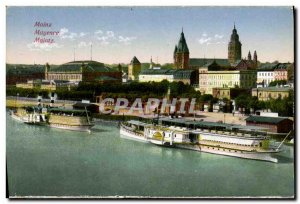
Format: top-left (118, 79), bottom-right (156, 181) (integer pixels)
top-left (228, 25), bottom-right (242, 64)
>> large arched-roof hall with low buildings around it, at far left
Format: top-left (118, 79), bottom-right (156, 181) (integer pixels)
top-left (12, 60), bottom-right (122, 90)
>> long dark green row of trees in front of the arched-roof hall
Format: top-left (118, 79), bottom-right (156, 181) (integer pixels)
top-left (6, 80), bottom-right (201, 102)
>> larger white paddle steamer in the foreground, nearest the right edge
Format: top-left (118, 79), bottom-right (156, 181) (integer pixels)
top-left (120, 120), bottom-right (281, 162)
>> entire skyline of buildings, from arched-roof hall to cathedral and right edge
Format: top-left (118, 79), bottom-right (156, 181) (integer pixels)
top-left (7, 26), bottom-right (293, 100)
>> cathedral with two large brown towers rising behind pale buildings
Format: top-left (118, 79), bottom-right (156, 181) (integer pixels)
top-left (173, 25), bottom-right (258, 70)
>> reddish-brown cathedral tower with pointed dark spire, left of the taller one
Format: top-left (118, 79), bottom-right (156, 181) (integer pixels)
top-left (174, 29), bottom-right (190, 69)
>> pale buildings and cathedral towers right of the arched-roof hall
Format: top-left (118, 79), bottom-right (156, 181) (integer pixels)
top-left (128, 26), bottom-right (294, 100)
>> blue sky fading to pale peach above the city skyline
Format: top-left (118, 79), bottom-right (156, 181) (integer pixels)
top-left (6, 6), bottom-right (294, 64)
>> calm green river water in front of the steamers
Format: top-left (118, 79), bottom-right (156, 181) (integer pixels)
top-left (6, 115), bottom-right (294, 197)
